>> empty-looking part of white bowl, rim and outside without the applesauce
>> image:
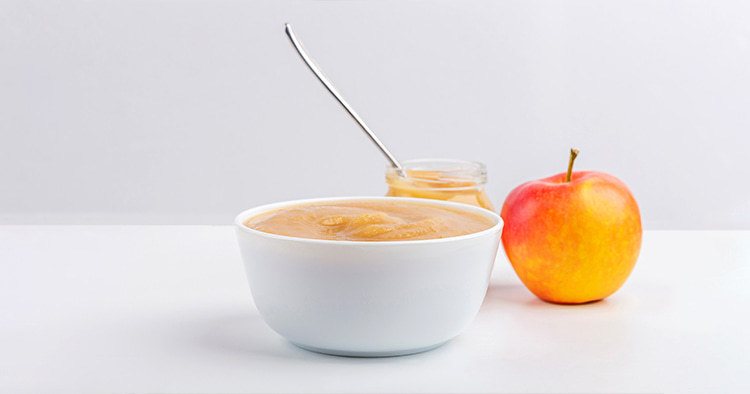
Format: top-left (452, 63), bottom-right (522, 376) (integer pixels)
top-left (235, 197), bottom-right (503, 357)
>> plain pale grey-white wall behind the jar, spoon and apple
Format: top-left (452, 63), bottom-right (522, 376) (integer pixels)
top-left (0, 0), bottom-right (750, 229)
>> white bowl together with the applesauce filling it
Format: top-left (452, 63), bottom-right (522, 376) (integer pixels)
top-left (235, 197), bottom-right (503, 357)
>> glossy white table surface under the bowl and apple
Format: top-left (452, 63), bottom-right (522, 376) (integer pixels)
top-left (0, 226), bottom-right (750, 393)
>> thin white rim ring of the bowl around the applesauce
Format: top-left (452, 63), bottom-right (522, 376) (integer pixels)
top-left (234, 196), bottom-right (504, 247)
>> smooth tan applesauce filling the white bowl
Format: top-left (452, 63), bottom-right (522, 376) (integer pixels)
top-left (245, 201), bottom-right (495, 241)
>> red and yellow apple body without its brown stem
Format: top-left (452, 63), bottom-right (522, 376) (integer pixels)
top-left (500, 171), bottom-right (642, 304)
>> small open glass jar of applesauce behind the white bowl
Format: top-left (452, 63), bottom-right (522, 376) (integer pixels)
top-left (385, 159), bottom-right (495, 211)
